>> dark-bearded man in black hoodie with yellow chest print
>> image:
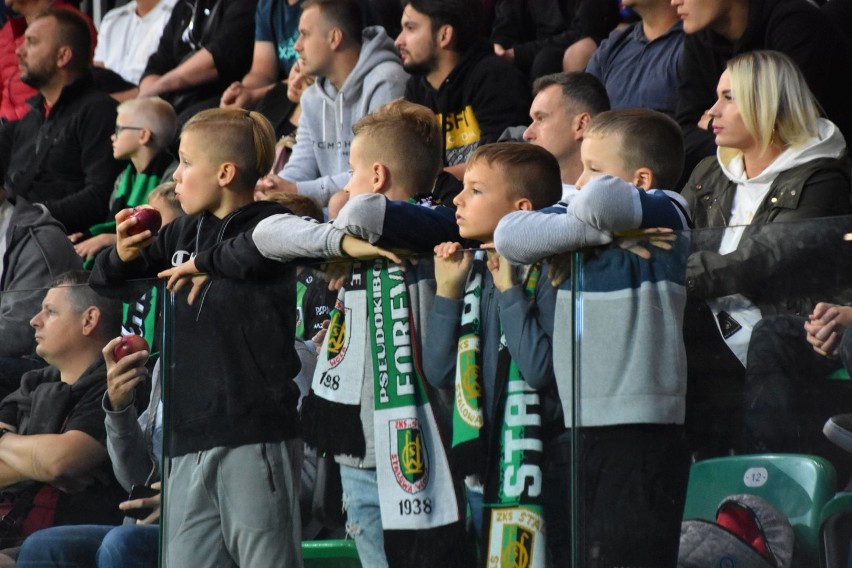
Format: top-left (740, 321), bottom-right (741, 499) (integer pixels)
top-left (396, 0), bottom-right (531, 205)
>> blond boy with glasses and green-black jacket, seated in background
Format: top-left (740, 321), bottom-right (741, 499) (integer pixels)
top-left (69, 97), bottom-right (177, 268)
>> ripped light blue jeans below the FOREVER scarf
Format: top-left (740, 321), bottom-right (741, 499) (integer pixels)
top-left (340, 464), bottom-right (388, 568)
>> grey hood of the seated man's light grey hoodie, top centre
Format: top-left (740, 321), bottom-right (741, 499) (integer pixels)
top-left (316, 26), bottom-right (402, 106)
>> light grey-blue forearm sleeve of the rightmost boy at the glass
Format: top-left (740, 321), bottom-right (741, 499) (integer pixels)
top-left (494, 206), bottom-right (612, 264)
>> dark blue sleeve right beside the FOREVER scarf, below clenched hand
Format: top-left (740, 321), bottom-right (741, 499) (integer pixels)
top-left (423, 296), bottom-right (462, 388)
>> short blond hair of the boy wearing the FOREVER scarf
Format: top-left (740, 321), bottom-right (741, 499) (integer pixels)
top-left (352, 99), bottom-right (443, 199)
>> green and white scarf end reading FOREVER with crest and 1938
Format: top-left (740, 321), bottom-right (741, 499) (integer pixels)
top-left (366, 260), bottom-right (459, 530)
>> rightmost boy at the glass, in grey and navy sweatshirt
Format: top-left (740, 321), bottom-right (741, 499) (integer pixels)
top-left (495, 109), bottom-right (689, 566)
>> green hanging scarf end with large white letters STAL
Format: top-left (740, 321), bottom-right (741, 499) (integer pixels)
top-left (483, 264), bottom-right (545, 568)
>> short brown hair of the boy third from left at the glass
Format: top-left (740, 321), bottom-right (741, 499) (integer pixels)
top-left (467, 142), bottom-right (562, 209)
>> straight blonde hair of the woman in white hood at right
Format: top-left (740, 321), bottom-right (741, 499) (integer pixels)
top-left (728, 50), bottom-right (820, 154)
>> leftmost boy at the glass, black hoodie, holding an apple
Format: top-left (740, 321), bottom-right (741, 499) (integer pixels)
top-left (91, 109), bottom-right (302, 567)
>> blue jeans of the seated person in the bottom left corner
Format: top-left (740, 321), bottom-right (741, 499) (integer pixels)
top-left (16, 525), bottom-right (160, 568)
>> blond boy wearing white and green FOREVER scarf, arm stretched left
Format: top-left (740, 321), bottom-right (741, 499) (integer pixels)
top-left (162, 100), bottom-right (469, 568)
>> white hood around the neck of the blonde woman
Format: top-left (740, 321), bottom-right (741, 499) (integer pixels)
top-left (716, 118), bottom-right (846, 185)
